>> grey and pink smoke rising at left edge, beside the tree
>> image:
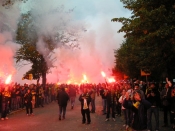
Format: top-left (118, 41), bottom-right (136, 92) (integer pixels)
top-left (0, 2), bottom-right (20, 82)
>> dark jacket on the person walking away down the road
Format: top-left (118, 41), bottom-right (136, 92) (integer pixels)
top-left (57, 89), bottom-right (69, 106)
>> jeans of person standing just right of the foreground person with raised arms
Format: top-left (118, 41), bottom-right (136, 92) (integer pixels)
top-left (147, 107), bottom-right (159, 130)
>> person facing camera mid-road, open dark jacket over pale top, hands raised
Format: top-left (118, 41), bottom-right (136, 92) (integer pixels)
top-left (79, 88), bottom-right (91, 124)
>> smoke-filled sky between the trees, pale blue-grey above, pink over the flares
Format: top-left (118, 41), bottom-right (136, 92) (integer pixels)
top-left (0, 0), bottom-right (130, 83)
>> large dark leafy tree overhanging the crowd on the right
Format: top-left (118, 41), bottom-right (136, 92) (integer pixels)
top-left (112, 0), bottom-right (175, 81)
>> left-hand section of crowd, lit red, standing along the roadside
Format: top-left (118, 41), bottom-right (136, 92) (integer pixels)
top-left (0, 83), bottom-right (57, 120)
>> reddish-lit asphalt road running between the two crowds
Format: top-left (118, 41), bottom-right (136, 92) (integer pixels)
top-left (0, 97), bottom-right (171, 131)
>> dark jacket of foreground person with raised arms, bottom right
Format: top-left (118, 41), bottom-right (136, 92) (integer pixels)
top-left (123, 99), bottom-right (151, 130)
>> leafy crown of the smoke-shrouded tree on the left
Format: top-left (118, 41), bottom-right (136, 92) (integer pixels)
top-left (15, 12), bottom-right (55, 82)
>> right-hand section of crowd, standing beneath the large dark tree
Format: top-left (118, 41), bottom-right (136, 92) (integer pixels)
top-left (100, 80), bottom-right (175, 131)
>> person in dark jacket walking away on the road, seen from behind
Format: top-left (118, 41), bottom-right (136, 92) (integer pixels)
top-left (57, 87), bottom-right (69, 120)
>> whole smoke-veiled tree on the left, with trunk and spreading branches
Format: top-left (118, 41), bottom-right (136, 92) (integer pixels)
top-left (15, 6), bottom-right (82, 86)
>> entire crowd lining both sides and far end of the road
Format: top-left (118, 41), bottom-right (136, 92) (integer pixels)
top-left (0, 79), bottom-right (175, 131)
